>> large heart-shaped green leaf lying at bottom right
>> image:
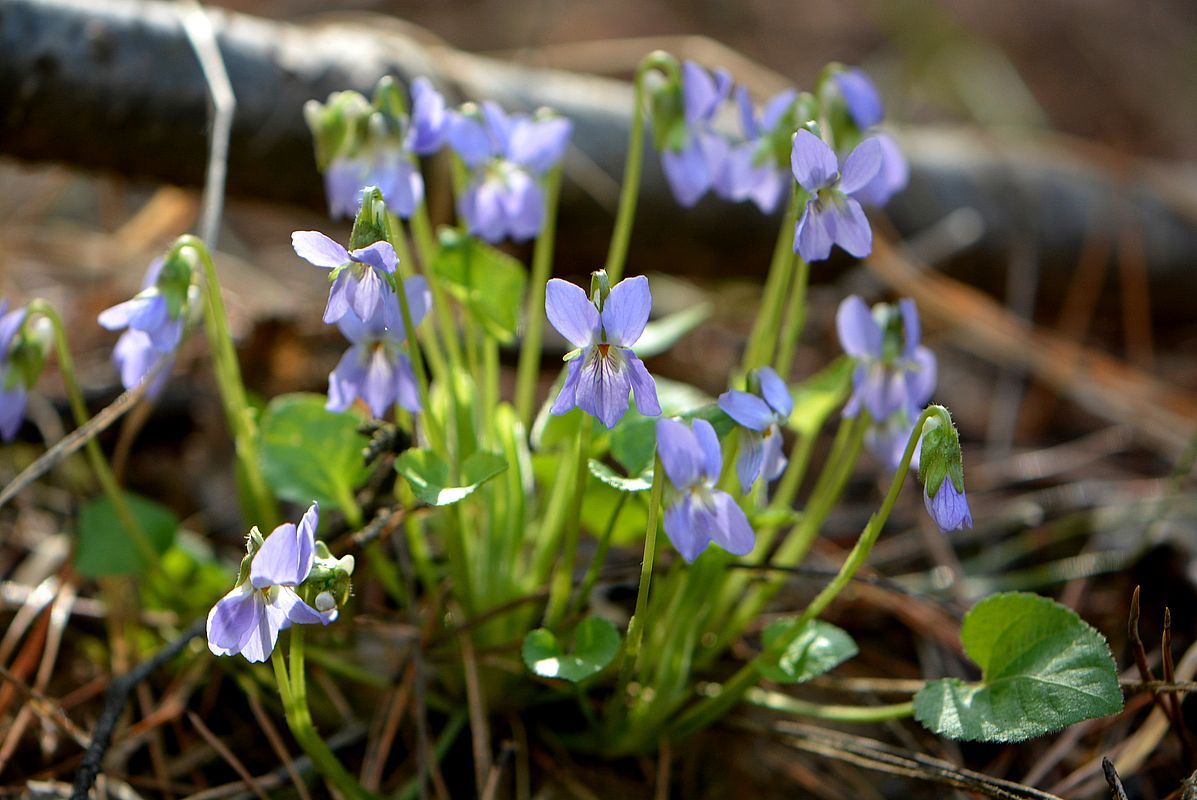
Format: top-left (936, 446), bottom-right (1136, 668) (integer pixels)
top-left (915, 593), bottom-right (1123, 741)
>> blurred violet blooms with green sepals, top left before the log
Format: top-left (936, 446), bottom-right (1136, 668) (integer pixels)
top-left (304, 78), bottom-right (446, 219)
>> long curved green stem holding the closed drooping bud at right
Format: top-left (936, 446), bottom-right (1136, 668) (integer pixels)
top-left (676, 406), bottom-right (950, 735)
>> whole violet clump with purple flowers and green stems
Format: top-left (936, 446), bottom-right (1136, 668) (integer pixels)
top-left (0, 53), bottom-right (1120, 798)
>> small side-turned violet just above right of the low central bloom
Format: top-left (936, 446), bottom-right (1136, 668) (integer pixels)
top-left (719, 366), bottom-right (794, 493)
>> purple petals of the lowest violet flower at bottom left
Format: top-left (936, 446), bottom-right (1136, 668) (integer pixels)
top-left (207, 503), bottom-right (336, 662)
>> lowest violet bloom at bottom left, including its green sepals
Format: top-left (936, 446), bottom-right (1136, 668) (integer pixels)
top-left (207, 503), bottom-right (353, 662)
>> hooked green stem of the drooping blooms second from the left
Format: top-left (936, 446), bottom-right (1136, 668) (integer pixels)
top-left (175, 236), bottom-right (279, 531)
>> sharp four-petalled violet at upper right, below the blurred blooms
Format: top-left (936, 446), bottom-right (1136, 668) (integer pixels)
top-left (790, 128), bottom-right (881, 262)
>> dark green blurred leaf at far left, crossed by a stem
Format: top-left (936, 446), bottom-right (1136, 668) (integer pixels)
top-left (74, 492), bottom-right (178, 577)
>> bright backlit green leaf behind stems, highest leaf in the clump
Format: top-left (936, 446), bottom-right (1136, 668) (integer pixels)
top-left (432, 228), bottom-right (528, 343)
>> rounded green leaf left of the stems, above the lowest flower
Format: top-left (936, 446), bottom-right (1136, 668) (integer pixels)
top-left (260, 394), bottom-right (369, 508)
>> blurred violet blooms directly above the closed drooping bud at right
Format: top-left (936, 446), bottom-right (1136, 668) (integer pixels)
top-left (836, 295), bottom-right (936, 469)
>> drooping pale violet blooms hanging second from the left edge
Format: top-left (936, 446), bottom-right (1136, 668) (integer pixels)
top-left (99, 250), bottom-right (199, 398)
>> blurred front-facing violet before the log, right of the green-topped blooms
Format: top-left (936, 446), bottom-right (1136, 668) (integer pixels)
top-left (448, 103), bottom-right (573, 242)
